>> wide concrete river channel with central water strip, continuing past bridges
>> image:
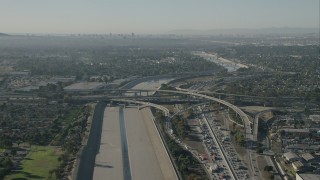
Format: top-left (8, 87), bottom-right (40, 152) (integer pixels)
top-left (77, 79), bottom-right (178, 180)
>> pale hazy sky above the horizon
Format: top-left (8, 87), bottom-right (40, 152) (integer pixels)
top-left (0, 0), bottom-right (320, 34)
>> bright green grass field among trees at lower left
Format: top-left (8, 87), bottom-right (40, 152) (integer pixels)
top-left (5, 146), bottom-right (59, 180)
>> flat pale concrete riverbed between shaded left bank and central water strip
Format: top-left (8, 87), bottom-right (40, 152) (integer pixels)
top-left (93, 107), bottom-right (123, 180)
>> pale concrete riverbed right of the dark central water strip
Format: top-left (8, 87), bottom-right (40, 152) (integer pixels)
top-left (124, 107), bottom-right (177, 180)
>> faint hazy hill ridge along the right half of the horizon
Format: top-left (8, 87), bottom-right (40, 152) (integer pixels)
top-left (168, 27), bottom-right (319, 35)
